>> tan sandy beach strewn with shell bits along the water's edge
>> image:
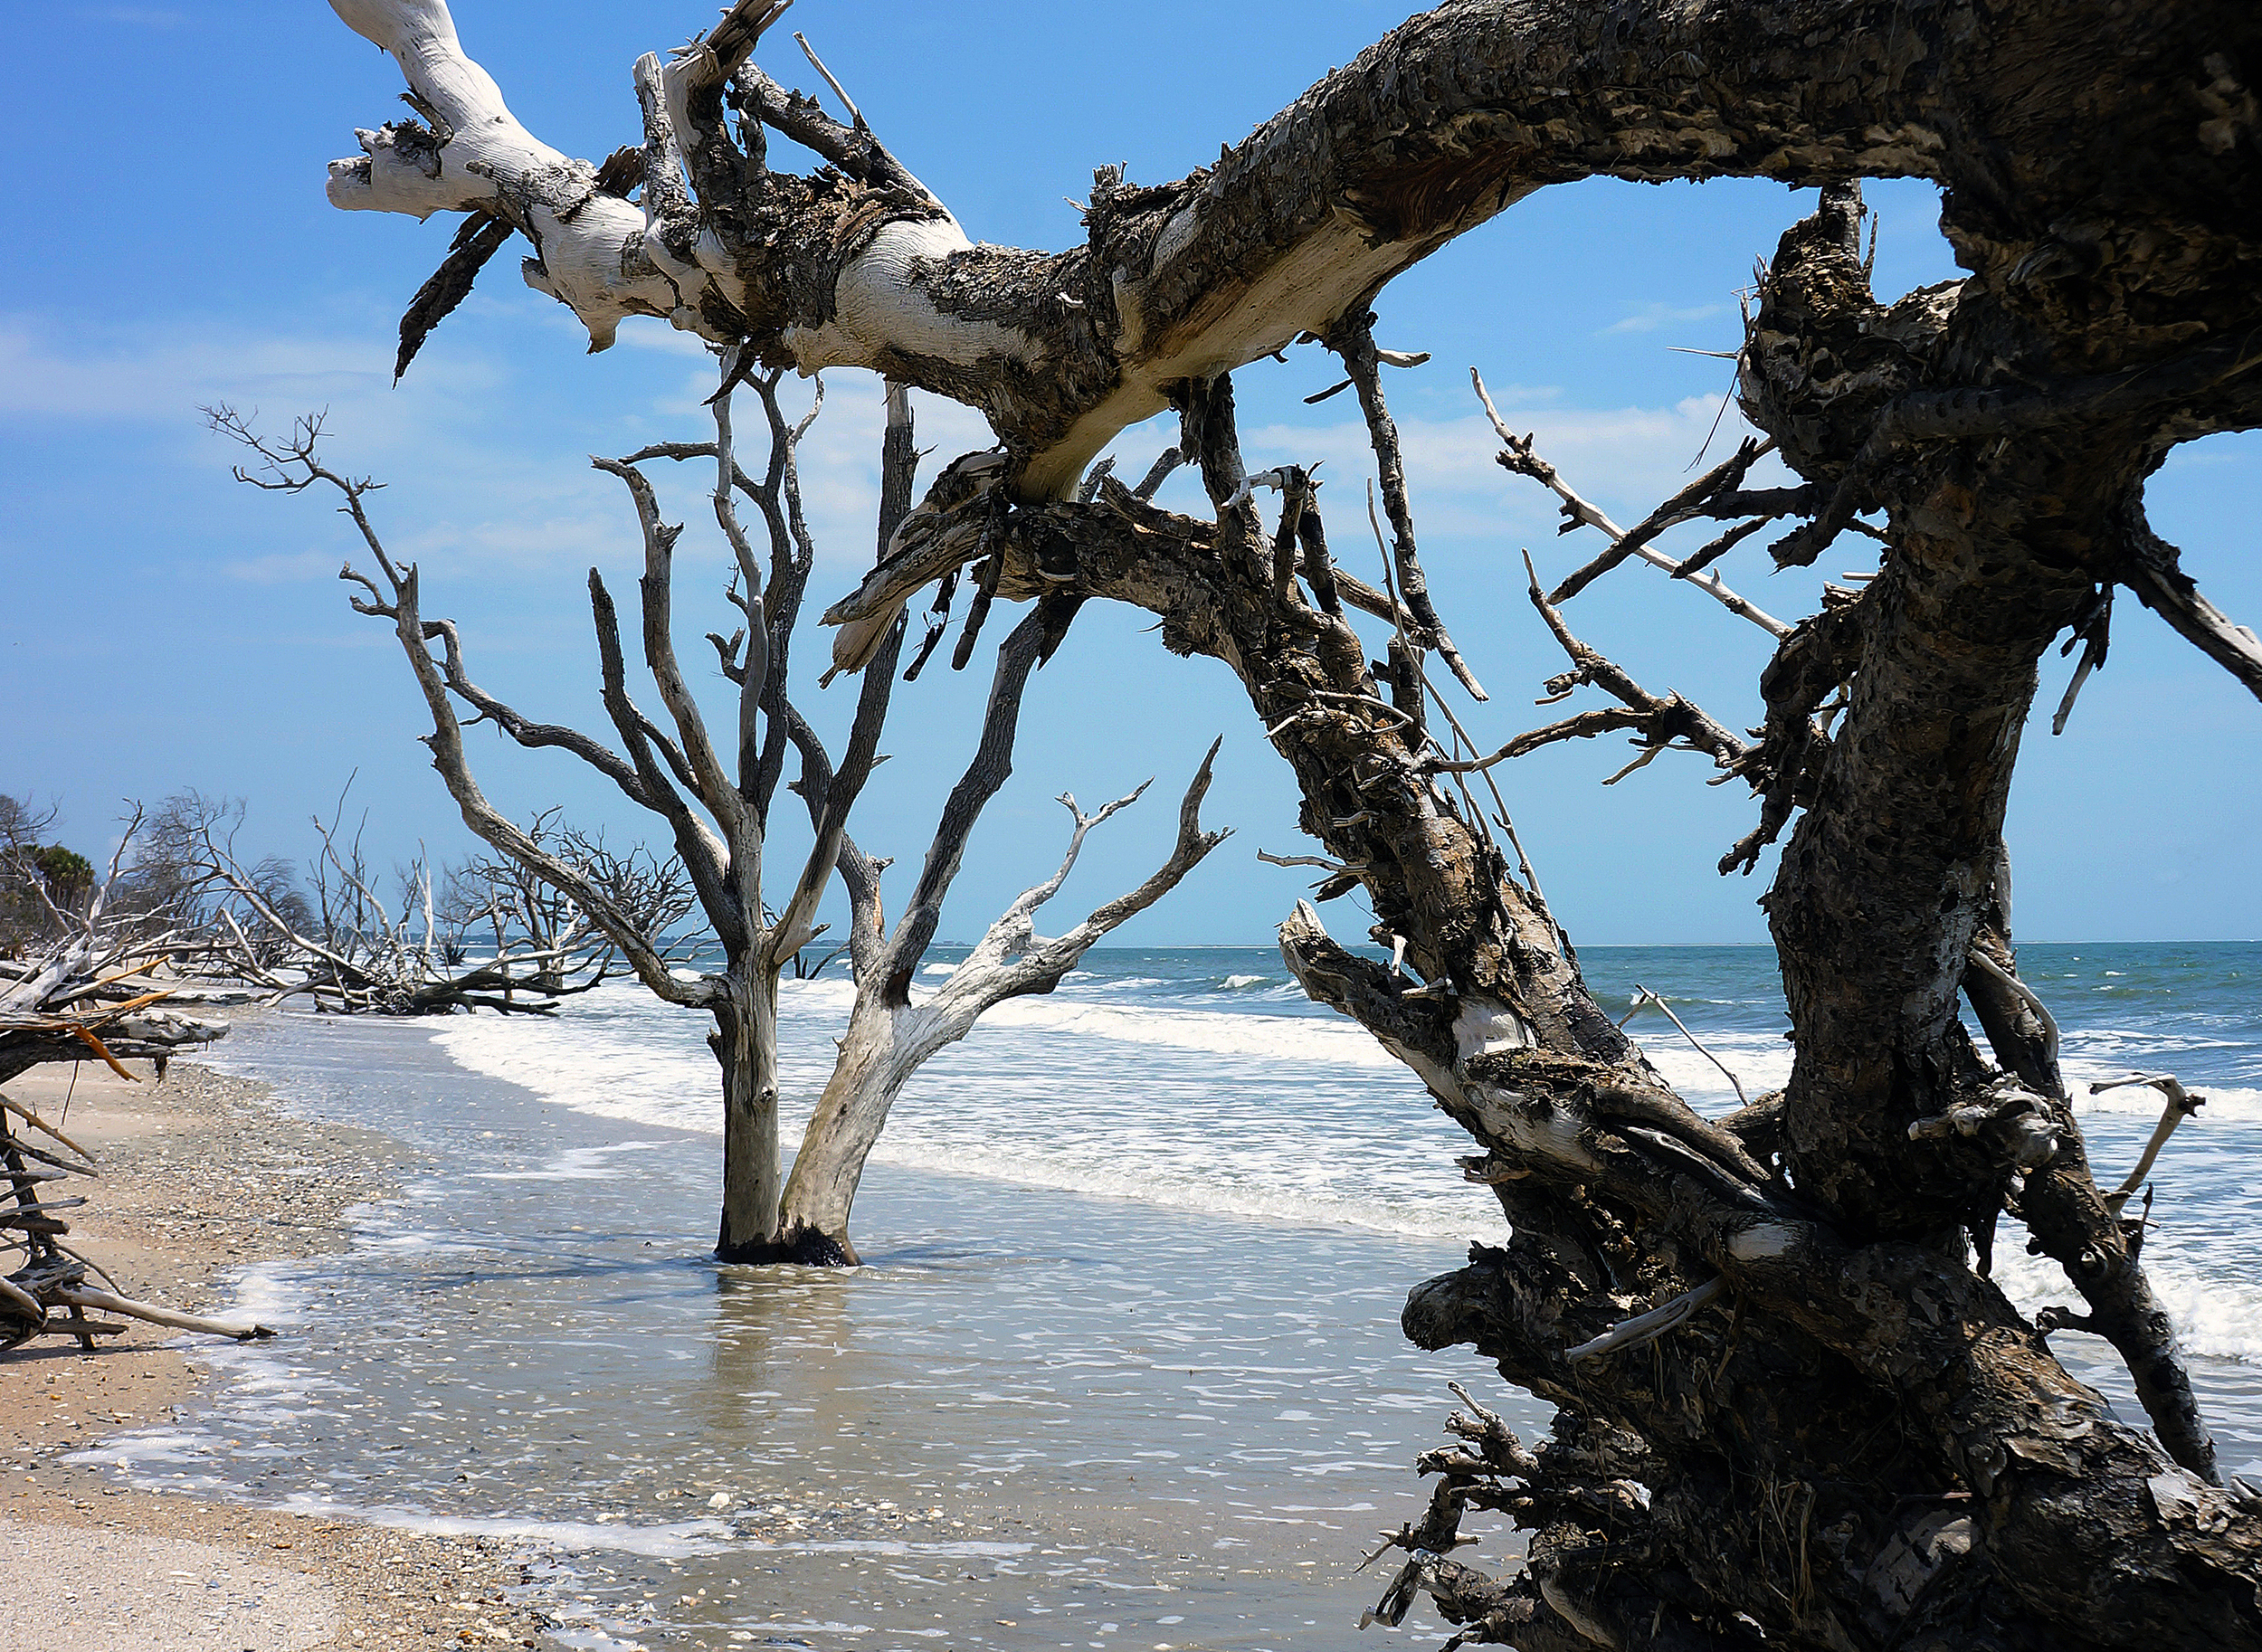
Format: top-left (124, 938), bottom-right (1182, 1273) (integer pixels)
top-left (0, 1061), bottom-right (546, 1652)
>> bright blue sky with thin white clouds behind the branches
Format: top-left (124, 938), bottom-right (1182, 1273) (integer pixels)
top-left (0, 0), bottom-right (2262, 944)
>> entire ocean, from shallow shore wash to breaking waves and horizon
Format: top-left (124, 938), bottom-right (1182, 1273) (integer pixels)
top-left (71, 944), bottom-right (2262, 1652)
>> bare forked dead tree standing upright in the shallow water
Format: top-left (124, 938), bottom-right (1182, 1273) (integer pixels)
top-left (213, 373), bottom-right (1224, 1265)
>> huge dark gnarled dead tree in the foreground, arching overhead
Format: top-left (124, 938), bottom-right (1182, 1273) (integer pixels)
top-left (330, 0), bottom-right (2262, 1652)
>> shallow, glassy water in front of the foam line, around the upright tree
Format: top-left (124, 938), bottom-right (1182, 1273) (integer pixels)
top-left (107, 1023), bottom-right (1538, 1647)
